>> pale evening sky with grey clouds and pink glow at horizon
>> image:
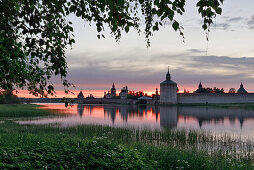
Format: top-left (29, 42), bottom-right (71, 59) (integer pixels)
top-left (18, 0), bottom-right (254, 96)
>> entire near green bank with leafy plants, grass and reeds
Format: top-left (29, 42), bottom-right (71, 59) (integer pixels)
top-left (0, 105), bottom-right (254, 169)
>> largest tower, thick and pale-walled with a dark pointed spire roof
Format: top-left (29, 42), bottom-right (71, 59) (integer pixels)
top-left (160, 69), bottom-right (177, 104)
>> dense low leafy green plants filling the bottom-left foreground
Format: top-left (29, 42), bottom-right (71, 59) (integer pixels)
top-left (0, 133), bottom-right (153, 169)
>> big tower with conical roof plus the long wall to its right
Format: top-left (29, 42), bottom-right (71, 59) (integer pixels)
top-left (160, 70), bottom-right (254, 104)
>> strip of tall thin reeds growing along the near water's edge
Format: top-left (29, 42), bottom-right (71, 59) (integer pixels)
top-left (0, 122), bottom-right (254, 160)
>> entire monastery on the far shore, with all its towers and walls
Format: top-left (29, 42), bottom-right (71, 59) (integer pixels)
top-left (78, 68), bottom-right (254, 104)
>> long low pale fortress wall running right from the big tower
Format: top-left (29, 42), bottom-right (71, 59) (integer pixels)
top-left (177, 93), bottom-right (254, 104)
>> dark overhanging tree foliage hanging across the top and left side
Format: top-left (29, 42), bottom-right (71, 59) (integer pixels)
top-left (0, 0), bottom-right (223, 96)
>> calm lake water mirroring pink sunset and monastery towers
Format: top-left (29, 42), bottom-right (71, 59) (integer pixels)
top-left (21, 104), bottom-right (254, 139)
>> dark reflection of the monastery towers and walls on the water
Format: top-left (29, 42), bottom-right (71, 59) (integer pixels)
top-left (77, 104), bottom-right (254, 128)
